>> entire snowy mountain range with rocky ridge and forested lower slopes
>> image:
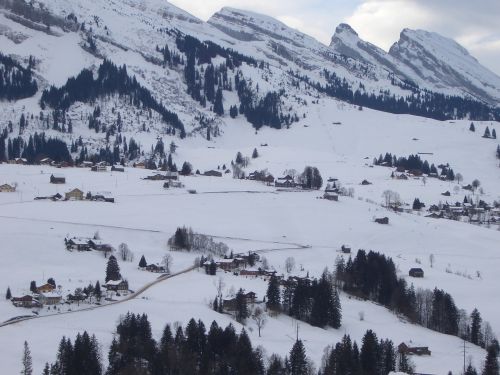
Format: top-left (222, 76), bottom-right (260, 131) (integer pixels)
top-left (0, 0), bottom-right (500, 162)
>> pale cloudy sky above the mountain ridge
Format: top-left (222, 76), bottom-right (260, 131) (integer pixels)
top-left (171, 0), bottom-right (500, 75)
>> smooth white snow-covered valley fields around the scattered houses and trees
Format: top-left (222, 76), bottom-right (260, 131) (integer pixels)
top-left (0, 100), bottom-right (500, 374)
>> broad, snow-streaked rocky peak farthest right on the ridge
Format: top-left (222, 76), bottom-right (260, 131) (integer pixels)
top-left (389, 29), bottom-right (500, 104)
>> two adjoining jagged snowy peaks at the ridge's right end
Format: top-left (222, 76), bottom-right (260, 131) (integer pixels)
top-left (330, 24), bottom-right (500, 104)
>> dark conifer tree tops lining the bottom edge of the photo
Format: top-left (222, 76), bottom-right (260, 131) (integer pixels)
top-left (30, 313), bottom-right (468, 375)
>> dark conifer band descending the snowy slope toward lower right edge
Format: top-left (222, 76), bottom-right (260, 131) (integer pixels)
top-left (335, 250), bottom-right (495, 347)
